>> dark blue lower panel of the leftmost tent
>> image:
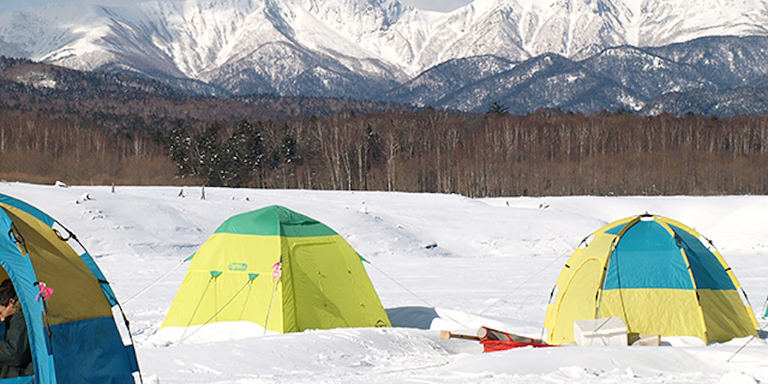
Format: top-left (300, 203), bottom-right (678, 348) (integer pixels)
top-left (51, 317), bottom-right (138, 384)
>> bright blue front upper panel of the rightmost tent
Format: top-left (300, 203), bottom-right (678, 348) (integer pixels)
top-left (603, 221), bottom-right (693, 289)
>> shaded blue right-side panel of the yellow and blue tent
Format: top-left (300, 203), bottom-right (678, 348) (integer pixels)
top-left (670, 225), bottom-right (736, 290)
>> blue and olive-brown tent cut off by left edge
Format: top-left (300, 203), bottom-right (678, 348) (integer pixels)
top-left (0, 194), bottom-right (138, 384)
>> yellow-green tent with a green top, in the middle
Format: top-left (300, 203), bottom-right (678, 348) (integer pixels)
top-left (161, 206), bottom-right (390, 340)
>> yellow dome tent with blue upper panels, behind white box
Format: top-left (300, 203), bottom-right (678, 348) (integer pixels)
top-left (544, 214), bottom-right (758, 344)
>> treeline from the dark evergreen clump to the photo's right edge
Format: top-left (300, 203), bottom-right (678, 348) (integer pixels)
top-left (160, 110), bottom-right (768, 196)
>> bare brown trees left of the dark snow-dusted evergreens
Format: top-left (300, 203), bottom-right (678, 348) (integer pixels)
top-left (0, 109), bottom-right (176, 185)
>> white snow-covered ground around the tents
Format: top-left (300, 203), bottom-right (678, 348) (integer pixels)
top-left (0, 182), bottom-right (768, 384)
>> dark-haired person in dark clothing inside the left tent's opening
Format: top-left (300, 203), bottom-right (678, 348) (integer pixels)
top-left (0, 280), bottom-right (34, 379)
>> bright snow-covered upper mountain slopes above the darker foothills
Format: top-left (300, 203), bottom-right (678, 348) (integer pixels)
top-left (6, 0), bottom-right (768, 80)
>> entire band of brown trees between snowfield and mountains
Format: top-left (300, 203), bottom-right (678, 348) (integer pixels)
top-left (0, 103), bottom-right (768, 196)
